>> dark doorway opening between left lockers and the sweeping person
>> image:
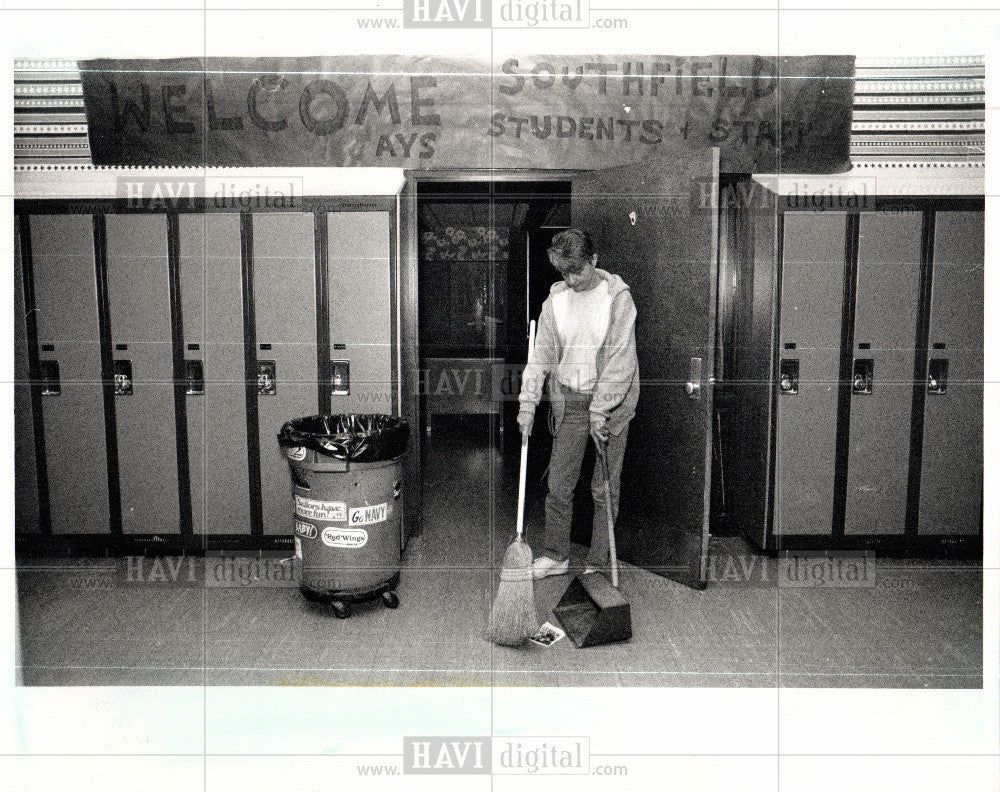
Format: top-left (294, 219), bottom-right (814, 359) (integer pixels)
top-left (415, 177), bottom-right (576, 557)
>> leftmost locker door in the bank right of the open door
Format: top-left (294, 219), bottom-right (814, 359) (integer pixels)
top-left (774, 212), bottom-right (847, 536)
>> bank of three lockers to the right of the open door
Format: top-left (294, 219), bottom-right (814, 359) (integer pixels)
top-left (743, 207), bottom-right (984, 547)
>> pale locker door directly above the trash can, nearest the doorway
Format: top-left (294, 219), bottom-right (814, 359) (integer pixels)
top-left (327, 212), bottom-right (395, 413)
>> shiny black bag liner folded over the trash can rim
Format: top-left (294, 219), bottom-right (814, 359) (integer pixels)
top-left (278, 413), bottom-right (410, 462)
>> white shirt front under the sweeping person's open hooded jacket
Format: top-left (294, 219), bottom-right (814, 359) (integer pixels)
top-left (552, 278), bottom-right (611, 393)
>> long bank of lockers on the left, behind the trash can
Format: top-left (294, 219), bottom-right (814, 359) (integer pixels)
top-left (15, 209), bottom-right (396, 537)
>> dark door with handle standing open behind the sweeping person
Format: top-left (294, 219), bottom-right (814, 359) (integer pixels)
top-left (572, 149), bottom-right (719, 588)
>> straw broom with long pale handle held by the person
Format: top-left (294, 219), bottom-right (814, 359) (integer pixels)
top-left (488, 322), bottom-right (538, 646)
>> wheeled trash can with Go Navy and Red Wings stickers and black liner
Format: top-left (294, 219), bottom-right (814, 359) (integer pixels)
top-left (278, 414), bottom-right (410, 619)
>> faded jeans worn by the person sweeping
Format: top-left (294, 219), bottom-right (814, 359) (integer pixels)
top-left (544, 386), bottom-right (628, 566)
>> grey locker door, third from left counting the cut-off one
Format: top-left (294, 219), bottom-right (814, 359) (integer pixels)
top-left (106, 214), bottom-right (180, 534)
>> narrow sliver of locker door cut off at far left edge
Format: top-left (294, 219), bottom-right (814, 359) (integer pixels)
top-left (14, 218), bottom-right (42, 534)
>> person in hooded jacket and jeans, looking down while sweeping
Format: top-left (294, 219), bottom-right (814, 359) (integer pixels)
top-left (517, 228), bottom-right (639, 579)
